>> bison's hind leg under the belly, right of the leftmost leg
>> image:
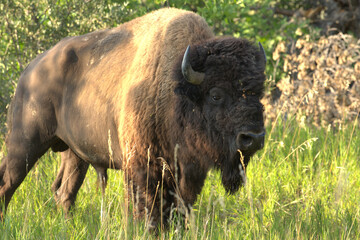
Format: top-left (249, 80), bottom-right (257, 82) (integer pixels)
top-left (51, 148), bottom-right (89, 217)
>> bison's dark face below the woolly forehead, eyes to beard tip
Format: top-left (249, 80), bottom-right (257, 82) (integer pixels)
top-left (203, 87), bottom-right (265, 193)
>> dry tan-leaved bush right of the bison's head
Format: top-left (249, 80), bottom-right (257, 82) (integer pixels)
top-left (265, 33), bottom-right (360, 126)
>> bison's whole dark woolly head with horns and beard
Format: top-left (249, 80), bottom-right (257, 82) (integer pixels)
top-left (176, 38), bottom-right (266, 193)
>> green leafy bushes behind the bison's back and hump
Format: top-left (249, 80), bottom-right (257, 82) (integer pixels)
top-left (0, 0), bottom-right (316, 133)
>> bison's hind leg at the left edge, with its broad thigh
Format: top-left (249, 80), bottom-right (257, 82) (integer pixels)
top-left (0, 94), bottom-right (59, 218)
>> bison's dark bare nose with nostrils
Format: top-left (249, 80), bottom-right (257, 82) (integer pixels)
top-left (236, 131), bottom-right (265, 151)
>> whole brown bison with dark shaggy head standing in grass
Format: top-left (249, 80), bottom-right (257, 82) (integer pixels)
top-left (0, 8), bottom-right (266, 229)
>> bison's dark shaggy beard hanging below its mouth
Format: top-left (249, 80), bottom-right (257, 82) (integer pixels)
top-left (221, 152), bottom-right (250, 194)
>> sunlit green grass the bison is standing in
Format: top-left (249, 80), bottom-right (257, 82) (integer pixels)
top-left (0, 118), bottom-right (360, 239)
